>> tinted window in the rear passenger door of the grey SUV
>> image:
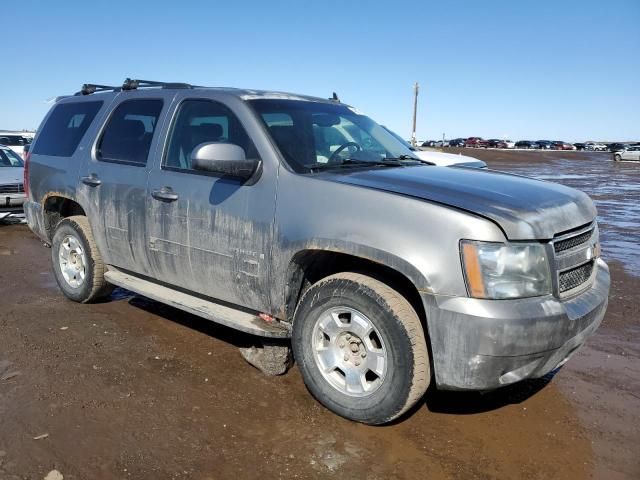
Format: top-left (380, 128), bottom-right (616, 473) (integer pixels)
top-left (97, 99), bottom-right (162, 165)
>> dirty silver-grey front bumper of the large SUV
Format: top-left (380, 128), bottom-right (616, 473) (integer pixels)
top-left (422, 259), bottom-right (611, 390)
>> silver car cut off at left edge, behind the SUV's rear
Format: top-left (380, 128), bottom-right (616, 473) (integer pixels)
top-left (0, 145), bottom-right (26, 220)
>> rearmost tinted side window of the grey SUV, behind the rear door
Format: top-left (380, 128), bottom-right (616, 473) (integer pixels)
top-left (33, 101), bottom-right (103, 157)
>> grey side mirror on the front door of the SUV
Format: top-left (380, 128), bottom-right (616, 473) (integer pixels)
top-left (191, 142), bottom-right (260, 180)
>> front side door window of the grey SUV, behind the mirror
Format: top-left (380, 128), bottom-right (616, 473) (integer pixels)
top-left (162, 100), bottom-right (258, 170)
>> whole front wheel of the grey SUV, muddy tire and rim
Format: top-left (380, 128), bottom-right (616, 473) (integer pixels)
top-left (292, 272), bottom-right (431, 425)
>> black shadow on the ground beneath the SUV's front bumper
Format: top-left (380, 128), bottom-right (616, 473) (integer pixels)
top-left (424, 370), bottom-right (557, 415)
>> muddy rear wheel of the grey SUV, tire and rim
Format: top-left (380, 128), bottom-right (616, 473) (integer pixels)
top-left (51, 215), bottom-right (113, 303)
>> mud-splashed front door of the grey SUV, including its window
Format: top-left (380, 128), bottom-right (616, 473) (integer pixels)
top-left (147, 97), bottom-right (277, 311)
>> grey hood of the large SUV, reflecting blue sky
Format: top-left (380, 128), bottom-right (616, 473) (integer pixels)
top-left (325, 166), bottom-right (596, 240)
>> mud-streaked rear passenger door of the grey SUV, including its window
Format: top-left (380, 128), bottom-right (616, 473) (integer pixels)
top-left (78, 91), bottom-right (171, 275)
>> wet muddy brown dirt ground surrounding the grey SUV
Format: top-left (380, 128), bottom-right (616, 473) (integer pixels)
top-left (0, 149), bottom-right (640, 480)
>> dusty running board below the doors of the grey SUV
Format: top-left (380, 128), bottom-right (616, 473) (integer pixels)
top-left (104, 267), bottom-right (291, 338)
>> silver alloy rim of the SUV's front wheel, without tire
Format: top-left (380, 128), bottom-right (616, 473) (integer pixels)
top-left (312, 307), bottom-right (388, 397)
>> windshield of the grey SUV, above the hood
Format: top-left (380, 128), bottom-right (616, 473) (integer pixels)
top-left (249, 99), bottom-right (424, 172)
